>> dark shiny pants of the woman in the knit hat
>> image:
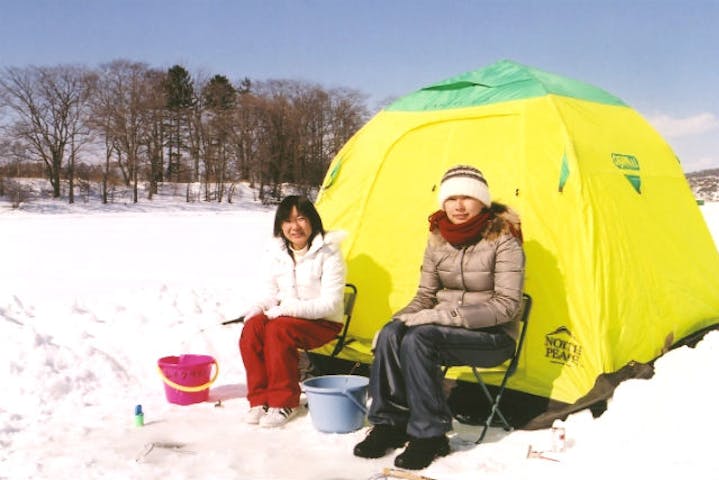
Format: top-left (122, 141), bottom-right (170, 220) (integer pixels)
top-left (368, 320), bottom-right (515, 438)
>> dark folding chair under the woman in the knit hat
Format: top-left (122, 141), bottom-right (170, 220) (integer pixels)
top-left (444, 293), bottom-right (532, 444)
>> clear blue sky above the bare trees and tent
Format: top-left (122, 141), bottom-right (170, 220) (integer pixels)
top-left (0, 0), bottom-right (719, 171)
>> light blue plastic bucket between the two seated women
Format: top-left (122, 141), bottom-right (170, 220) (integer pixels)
top-left (302, 375), bottom-right (369, 433)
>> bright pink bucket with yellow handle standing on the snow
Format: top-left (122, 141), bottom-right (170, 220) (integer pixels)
top-left (157, 354), bottom-right (220, 405)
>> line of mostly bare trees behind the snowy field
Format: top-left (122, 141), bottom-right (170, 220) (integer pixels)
top-left (0, 60), bottom-right (369, 203)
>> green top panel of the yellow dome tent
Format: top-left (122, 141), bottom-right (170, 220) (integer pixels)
top-left (385, 60), bottom-right (626, 111)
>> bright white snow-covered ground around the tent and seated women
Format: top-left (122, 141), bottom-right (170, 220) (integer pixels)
top-left (0, 194), bottom-right (719, 480)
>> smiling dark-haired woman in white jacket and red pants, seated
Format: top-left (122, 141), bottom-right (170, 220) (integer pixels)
top-left (240, 195), bottom-right (346, 427)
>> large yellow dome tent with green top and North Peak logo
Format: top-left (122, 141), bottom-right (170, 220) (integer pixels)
top-left (317, 61), bottom-right (719, 404)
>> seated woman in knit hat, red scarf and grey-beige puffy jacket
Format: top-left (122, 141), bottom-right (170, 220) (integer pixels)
top-left (354, 165), bottom-right (525, 469)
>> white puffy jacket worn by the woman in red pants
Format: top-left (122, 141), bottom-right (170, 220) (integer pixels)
top-left (257, 231), bottom-right (347, 323)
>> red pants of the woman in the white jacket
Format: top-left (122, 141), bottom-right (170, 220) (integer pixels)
top-left (240, 313), bottom-right (342, 408)
